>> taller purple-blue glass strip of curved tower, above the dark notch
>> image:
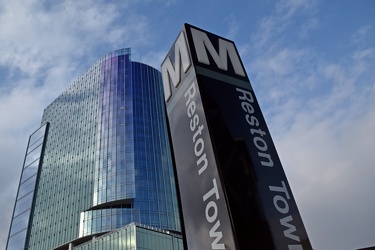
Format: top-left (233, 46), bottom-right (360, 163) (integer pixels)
top-left (93, 50), bottom-right (135, 206)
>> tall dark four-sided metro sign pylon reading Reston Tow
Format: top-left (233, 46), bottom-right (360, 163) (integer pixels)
top-left (161, 24), bottom-right (312, 250)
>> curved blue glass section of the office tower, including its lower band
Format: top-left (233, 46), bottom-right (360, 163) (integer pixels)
top-left (84, 50), bottom-right (180, 236)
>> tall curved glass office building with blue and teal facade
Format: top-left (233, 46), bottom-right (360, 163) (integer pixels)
top-left (7, 49), bottom-right (182, 250)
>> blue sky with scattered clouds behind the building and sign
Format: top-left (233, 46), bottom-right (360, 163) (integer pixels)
top-left (0, 0), bottom-right (375, 250)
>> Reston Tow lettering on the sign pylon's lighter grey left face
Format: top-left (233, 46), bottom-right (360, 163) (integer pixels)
top-left (184, 82), bottom-right (225, 249)
